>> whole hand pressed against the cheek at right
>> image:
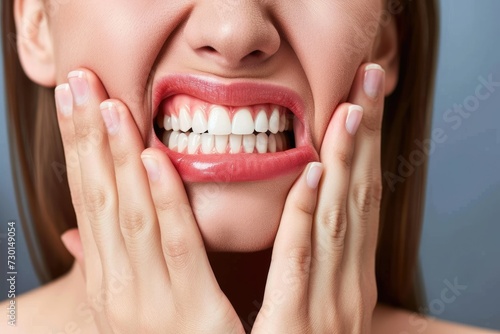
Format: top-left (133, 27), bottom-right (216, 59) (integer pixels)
top-left (252, 64), bottom-right (385, 334)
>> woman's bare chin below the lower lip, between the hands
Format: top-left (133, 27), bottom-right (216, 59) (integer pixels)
top-left (185, 171), bottom-right (300, 252)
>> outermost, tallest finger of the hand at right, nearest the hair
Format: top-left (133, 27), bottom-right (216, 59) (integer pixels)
top-left (346, 64), bottom-right (385, 266)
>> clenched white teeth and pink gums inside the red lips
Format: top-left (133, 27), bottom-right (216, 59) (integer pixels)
top-left (155, 94), bottom-right (295, 155)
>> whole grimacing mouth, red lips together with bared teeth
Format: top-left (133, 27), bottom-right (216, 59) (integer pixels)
top-left (150, 75), bottom-right (318, 182)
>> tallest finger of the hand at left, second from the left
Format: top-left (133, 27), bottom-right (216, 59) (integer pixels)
top-left (68, 70), bottom-right (127, 272)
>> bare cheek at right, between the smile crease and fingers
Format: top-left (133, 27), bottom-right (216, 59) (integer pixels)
top-left (284, 0), bottom-right (381, 149)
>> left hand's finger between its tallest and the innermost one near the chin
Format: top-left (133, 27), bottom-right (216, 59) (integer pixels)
top-left (101, 100), bottom-right (166, 282)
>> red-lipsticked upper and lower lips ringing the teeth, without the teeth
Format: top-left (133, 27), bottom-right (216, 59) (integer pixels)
top-left (149, 75), bottom-right (319, 182)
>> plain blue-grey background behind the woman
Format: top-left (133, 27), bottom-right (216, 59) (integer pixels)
top-left (0, 0), bottom-right (500, 329)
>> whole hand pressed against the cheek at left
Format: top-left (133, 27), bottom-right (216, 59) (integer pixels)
top-left (55, 70), bottom-right (244, 334)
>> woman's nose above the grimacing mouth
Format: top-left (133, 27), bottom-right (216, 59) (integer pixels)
top-left (184, 0), bottom-right (281, 69)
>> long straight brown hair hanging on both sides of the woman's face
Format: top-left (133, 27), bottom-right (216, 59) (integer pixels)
top-left (2, 0), bottom-right (438, 311)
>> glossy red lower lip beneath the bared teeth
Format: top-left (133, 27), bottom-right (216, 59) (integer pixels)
top-left (151, 135), bottom-right (318, 182)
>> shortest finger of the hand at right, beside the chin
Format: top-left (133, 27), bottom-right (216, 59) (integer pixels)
top-left (262, 162), bottom-right (323, 314)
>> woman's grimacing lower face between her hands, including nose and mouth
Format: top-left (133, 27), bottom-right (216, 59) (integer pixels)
top-left (49, 0), bottom-right (382, 251)
